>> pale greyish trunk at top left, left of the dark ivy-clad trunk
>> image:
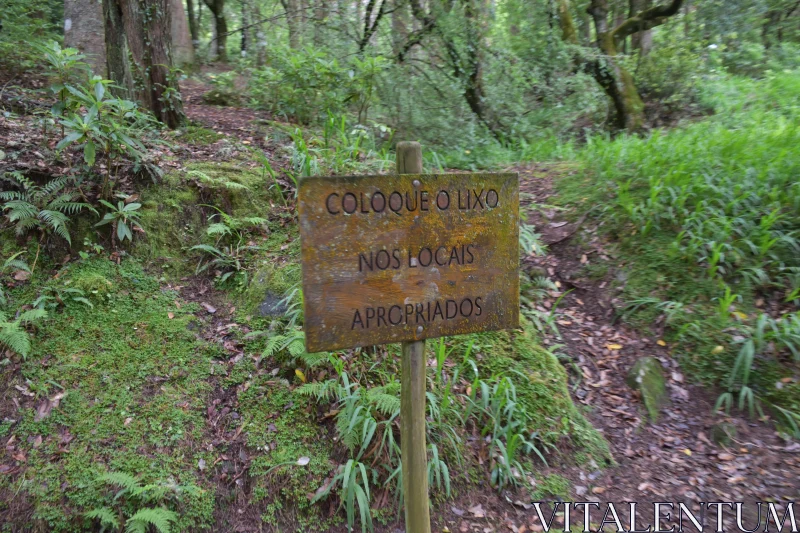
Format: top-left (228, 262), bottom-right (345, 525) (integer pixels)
top-left (64, 0), bottom-right (107, 78)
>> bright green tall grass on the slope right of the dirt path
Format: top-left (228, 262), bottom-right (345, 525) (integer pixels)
top-left (558, 72), bottom-right (800, 430)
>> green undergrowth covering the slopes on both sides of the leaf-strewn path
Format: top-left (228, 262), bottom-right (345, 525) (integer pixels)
top-left (0, 26), bottom-right (800, 532)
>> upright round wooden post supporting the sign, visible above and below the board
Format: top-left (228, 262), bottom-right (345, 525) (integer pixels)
top-left (396, 142), bottom-right (431, 533)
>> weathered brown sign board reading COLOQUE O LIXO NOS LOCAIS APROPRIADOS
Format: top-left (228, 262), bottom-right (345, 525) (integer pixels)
top-left (298, 174), bottom-right (519, 352)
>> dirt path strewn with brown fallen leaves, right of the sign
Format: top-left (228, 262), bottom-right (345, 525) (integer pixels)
top-left (181, 93), bottom-right (800, 533)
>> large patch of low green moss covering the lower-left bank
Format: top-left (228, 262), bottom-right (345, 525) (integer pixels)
top-left (0, 258), bottom-right (214, 531)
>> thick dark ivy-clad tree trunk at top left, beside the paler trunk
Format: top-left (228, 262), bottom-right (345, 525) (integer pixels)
top-left (105, 0), bottom-right (186, 128)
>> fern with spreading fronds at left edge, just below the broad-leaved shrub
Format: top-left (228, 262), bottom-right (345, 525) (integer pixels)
top-left (0, 172), bottom-right (94, 244)
